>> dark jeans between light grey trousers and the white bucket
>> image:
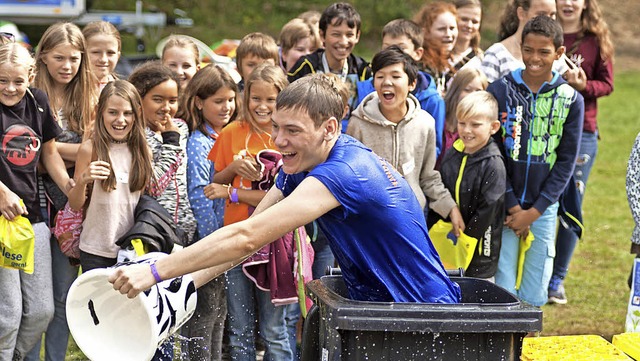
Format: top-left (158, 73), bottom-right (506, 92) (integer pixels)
top-left (24, 236), bottom-right (78, 361)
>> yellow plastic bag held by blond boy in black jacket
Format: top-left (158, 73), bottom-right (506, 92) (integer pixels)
top-left (429, 220), bottom-right (478, 270)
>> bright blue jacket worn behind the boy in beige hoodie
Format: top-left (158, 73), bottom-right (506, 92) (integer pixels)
top-left (356, 71), bottom-right (445, 158)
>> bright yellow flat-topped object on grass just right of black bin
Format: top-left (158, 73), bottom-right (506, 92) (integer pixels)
top-left (520, 335), bottom-right (631, 361)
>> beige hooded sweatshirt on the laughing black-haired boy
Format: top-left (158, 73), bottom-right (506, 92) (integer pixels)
top-left (347, 92), bottom-right (456, 217)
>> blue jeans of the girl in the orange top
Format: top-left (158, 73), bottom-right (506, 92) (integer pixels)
top-left (227, 265), bottom-right (293, 361)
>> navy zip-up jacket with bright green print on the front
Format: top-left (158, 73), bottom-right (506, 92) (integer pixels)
top-left (487, 69), bottom-right (584, 214)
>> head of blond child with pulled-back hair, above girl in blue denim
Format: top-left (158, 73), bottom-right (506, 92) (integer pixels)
top-left (161, 35), bottom-right (200, 89)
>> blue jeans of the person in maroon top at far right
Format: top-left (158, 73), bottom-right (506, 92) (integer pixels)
top-left (553, 132), bottom-right (598, 279)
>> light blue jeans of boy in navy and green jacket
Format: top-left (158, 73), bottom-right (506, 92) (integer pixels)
top-left (496, 203), bottom-right (558, 307)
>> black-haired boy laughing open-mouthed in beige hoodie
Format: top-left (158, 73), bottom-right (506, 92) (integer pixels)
top-left (347, 45), bottom-right (464, 235)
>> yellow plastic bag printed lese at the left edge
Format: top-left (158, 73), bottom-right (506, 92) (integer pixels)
top-left (0, 211), bottom-right (36, 274)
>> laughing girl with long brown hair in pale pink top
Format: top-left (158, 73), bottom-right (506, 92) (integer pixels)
top-left (69, 80), bottom-right (153, 272)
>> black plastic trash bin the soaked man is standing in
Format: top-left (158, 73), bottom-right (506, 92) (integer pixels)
top-left (301, 276), bottom-right (542, 361)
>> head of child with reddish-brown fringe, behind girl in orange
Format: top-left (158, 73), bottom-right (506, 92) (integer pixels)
top-left (236, 33), bottom-right (280, 93)
